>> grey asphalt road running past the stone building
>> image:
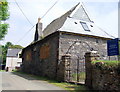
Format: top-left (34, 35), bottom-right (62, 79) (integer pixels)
top-left (0, 72), bottom-right (64, 92)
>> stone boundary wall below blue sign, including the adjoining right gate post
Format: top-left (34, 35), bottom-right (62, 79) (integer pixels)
top-left (85, 52), bottom-right (120, 92)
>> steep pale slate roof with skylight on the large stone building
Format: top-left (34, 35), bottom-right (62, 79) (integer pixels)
top-left (43, 3), bottom-right (113, 38)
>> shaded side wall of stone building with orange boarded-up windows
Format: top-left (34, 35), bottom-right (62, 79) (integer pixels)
top-left (22, 32), bottom-right (59, 78)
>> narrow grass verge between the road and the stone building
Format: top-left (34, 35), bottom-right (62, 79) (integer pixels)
top-left (14, 71), bottom-right (89, 92)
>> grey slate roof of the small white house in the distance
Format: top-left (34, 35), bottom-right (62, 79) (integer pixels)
top-left (7, 48), bottom-right (22, 57)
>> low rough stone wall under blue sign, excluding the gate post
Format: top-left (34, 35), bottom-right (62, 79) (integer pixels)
top-left (92, 64), bottom-right (120, 92)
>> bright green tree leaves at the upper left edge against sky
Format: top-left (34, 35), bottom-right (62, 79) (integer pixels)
top-left (0, 0), bottom-right (9, 40)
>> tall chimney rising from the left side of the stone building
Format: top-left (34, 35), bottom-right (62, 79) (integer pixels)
top-left (34, 18), bottom-right (43, 41)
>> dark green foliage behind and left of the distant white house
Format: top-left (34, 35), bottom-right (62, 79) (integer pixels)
top-left (1, 42), bottom-right (23, 64)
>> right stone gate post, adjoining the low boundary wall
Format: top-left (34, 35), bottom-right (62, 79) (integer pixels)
top-left (85, 51), bottom-right (99, 88)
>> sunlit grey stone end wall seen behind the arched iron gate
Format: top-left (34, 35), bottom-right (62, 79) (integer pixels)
top-left (59, 32), bottom-right (113, 83)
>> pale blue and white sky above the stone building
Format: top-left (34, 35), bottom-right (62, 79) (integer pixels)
top-left (0, 0), bottom-right (119, 47)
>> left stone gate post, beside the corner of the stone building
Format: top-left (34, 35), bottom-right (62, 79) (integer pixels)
top-left (57, 54), bottom-right (71, 81)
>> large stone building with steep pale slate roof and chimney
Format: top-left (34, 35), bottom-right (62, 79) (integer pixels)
top-left (22, 3), bottom-right (117, 79)
